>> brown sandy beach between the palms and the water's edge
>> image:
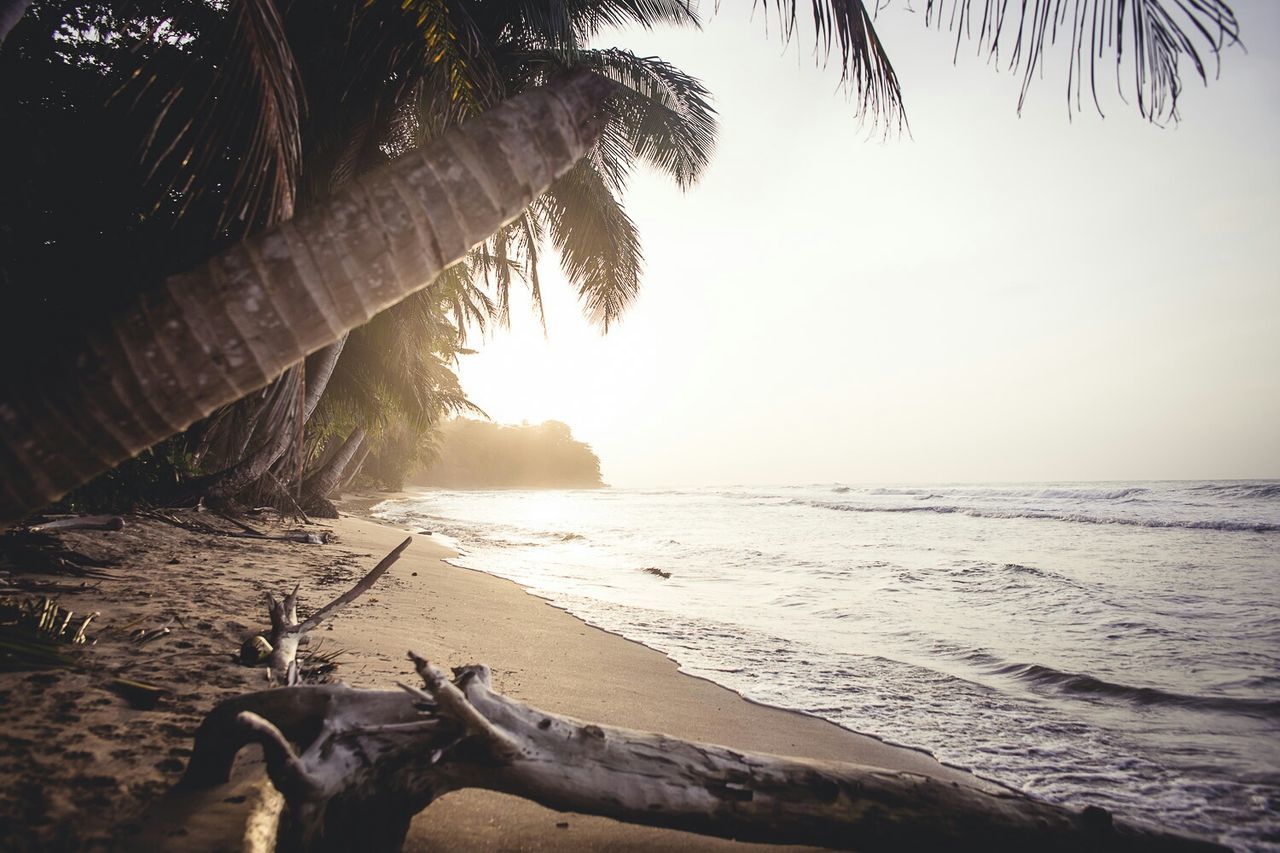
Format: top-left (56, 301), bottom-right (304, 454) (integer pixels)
top-left (0, 501), bottom-right (996, 850)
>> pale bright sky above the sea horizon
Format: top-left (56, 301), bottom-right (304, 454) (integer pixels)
top-left (460, 0), bottom-right (1280, 487)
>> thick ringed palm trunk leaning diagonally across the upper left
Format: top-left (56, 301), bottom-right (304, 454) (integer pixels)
top-left (0, 72), bottom-right (613, 526)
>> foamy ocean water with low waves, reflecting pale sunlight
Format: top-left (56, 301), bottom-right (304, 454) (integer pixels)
top-left (374, 482), bottom-right (1280, 849)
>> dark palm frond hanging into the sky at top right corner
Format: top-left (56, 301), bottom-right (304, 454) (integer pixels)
top-left (925, 0), bottom-right (1240, 122)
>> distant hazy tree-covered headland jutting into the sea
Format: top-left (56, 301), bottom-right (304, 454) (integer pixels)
top-left (410, 418), bottom-right (604, 489)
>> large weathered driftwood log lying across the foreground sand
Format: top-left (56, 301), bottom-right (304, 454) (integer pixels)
top-left (183, 654), bottom-right (1221, 850)
